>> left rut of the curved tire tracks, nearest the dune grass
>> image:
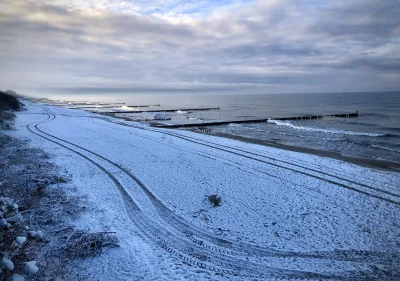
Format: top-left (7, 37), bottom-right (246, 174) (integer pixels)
top-left (27, 113), bottom-right (366, 280)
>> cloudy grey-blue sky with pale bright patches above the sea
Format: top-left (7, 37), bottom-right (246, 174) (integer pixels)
top-left (0, 0), bottom-right (400, 95)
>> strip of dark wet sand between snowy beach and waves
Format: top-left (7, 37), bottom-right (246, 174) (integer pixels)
top-left (183, 129), bottom-right (400, 173)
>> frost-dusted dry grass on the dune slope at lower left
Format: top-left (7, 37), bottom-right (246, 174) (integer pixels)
top-left (0, 131), bottom-right (82, 280)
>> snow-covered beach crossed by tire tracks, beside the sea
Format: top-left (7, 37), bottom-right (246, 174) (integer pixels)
top-left (6, 101), bottom-right (400, 280)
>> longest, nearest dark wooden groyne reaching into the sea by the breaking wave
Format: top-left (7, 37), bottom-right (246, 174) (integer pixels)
top-left (155, 111), bottom-right (358, 129)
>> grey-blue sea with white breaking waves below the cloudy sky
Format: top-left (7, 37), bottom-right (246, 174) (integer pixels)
top-left (42, 92), bottom-right (400, 163)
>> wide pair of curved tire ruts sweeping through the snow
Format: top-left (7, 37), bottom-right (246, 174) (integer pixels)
top-left (22, 109), bottom-right (400, 280)
